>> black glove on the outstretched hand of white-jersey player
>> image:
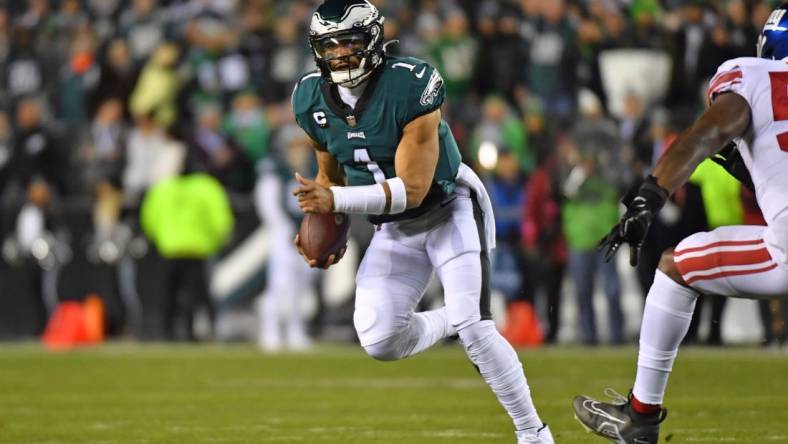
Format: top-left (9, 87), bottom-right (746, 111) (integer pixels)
top-left (598, 176), bottom-right (668, 267)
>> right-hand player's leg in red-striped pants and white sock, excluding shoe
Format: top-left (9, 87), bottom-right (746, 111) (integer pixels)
top-left (633, 226), bottom-right (788, 406)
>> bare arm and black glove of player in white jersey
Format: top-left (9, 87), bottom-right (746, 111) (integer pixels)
top-left (599, 93), bottom-right (752, 266)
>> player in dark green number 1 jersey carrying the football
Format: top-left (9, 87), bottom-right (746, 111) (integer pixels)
top-left (292, 0), bottom-right (553, 443)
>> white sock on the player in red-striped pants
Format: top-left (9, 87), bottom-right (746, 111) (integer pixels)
top-left (632, 270), bottom-right (698, 404)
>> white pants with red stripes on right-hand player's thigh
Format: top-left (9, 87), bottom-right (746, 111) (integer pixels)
top-left (673, 225), bottom-right (788, 298)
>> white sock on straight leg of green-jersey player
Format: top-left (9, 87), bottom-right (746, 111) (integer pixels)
top-left (459, 321), bottom-right (542, 430)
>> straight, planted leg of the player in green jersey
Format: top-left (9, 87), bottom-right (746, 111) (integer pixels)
top-left (427, 192), bottom-right (553, 443)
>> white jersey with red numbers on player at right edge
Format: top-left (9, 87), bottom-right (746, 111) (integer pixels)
top-left (708, 57), bottom-right (788, 234)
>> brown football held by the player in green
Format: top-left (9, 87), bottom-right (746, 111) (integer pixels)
top-left (298, 213), bottom-right (350, 264)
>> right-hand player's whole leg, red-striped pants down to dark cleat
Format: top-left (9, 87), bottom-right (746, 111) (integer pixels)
top-left (574, 226), bottom-right (788, 443)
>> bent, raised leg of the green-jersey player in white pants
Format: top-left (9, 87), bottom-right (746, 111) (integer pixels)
top-left (353, 229), bottom-right (455, 361)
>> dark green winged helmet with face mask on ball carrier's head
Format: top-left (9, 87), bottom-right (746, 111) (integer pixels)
top-left (309, 0), bottom-right (383, 87)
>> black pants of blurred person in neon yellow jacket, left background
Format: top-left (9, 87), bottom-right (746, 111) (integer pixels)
top-left (164, 259), bottom-right (214, 341)
